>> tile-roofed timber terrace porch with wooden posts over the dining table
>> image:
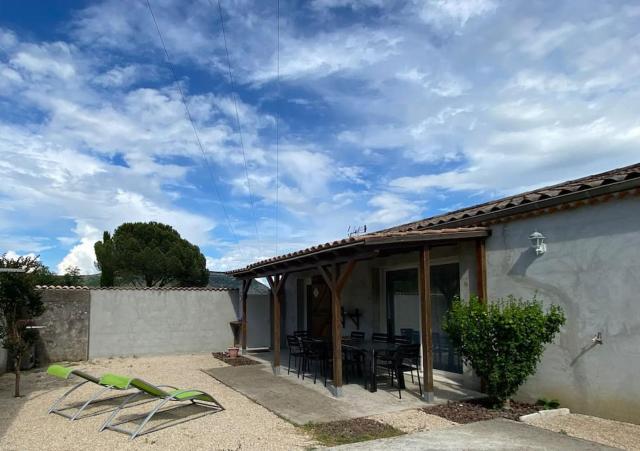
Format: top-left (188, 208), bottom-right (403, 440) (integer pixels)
top-left (230, 227), bottom-right (490, 402)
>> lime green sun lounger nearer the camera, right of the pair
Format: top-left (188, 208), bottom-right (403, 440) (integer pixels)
top-left (100, 374), bottom-right (224, 440)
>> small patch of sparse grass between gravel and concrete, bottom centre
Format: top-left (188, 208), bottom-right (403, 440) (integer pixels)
top-left (302, 418), bottom-right (404, 446)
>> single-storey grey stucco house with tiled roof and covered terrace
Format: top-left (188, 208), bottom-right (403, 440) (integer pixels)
top-left (229, 164), bottom-right (640, 422)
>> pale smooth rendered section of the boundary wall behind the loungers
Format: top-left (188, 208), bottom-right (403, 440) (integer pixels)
top-left (89, 290), bottom-right (240, 359)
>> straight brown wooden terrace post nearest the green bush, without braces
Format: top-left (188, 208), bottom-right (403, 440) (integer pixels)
top-left (419, 246), bottom-right (433, 402)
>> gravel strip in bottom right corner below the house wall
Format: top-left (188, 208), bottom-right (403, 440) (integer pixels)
top-left (527, 413), bottom-right (640, 450)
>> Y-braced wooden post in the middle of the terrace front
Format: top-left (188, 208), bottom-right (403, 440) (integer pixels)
top-left (318, 260), bottom-right (356, 396)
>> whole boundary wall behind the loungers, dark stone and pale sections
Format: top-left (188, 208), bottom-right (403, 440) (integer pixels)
top-left (25, 286), bottom-right (252, 366)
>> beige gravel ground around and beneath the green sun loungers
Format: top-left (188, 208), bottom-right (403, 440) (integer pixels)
top-left (0, 354), bottom-right (314, 451)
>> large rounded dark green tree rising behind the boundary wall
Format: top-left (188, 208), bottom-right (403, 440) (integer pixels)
top-left (95, 222), bottom-right (209, 287)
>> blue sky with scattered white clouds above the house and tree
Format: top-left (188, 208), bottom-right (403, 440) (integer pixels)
top-left (0, 0), bottom-right (640, 272)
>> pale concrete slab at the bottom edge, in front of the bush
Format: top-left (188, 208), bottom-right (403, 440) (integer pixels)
top-left (331, 419), bottom-right (616, 451)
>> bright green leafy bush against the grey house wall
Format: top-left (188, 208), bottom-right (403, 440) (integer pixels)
top-left (443, 296), bottom-right (565, 407)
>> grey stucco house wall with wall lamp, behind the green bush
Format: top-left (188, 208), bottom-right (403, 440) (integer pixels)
top-left (487, 197), bottom-right (640, 422)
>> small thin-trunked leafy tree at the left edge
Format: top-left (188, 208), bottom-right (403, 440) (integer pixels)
top-left (0, 254), bottom-right (44, 397)
